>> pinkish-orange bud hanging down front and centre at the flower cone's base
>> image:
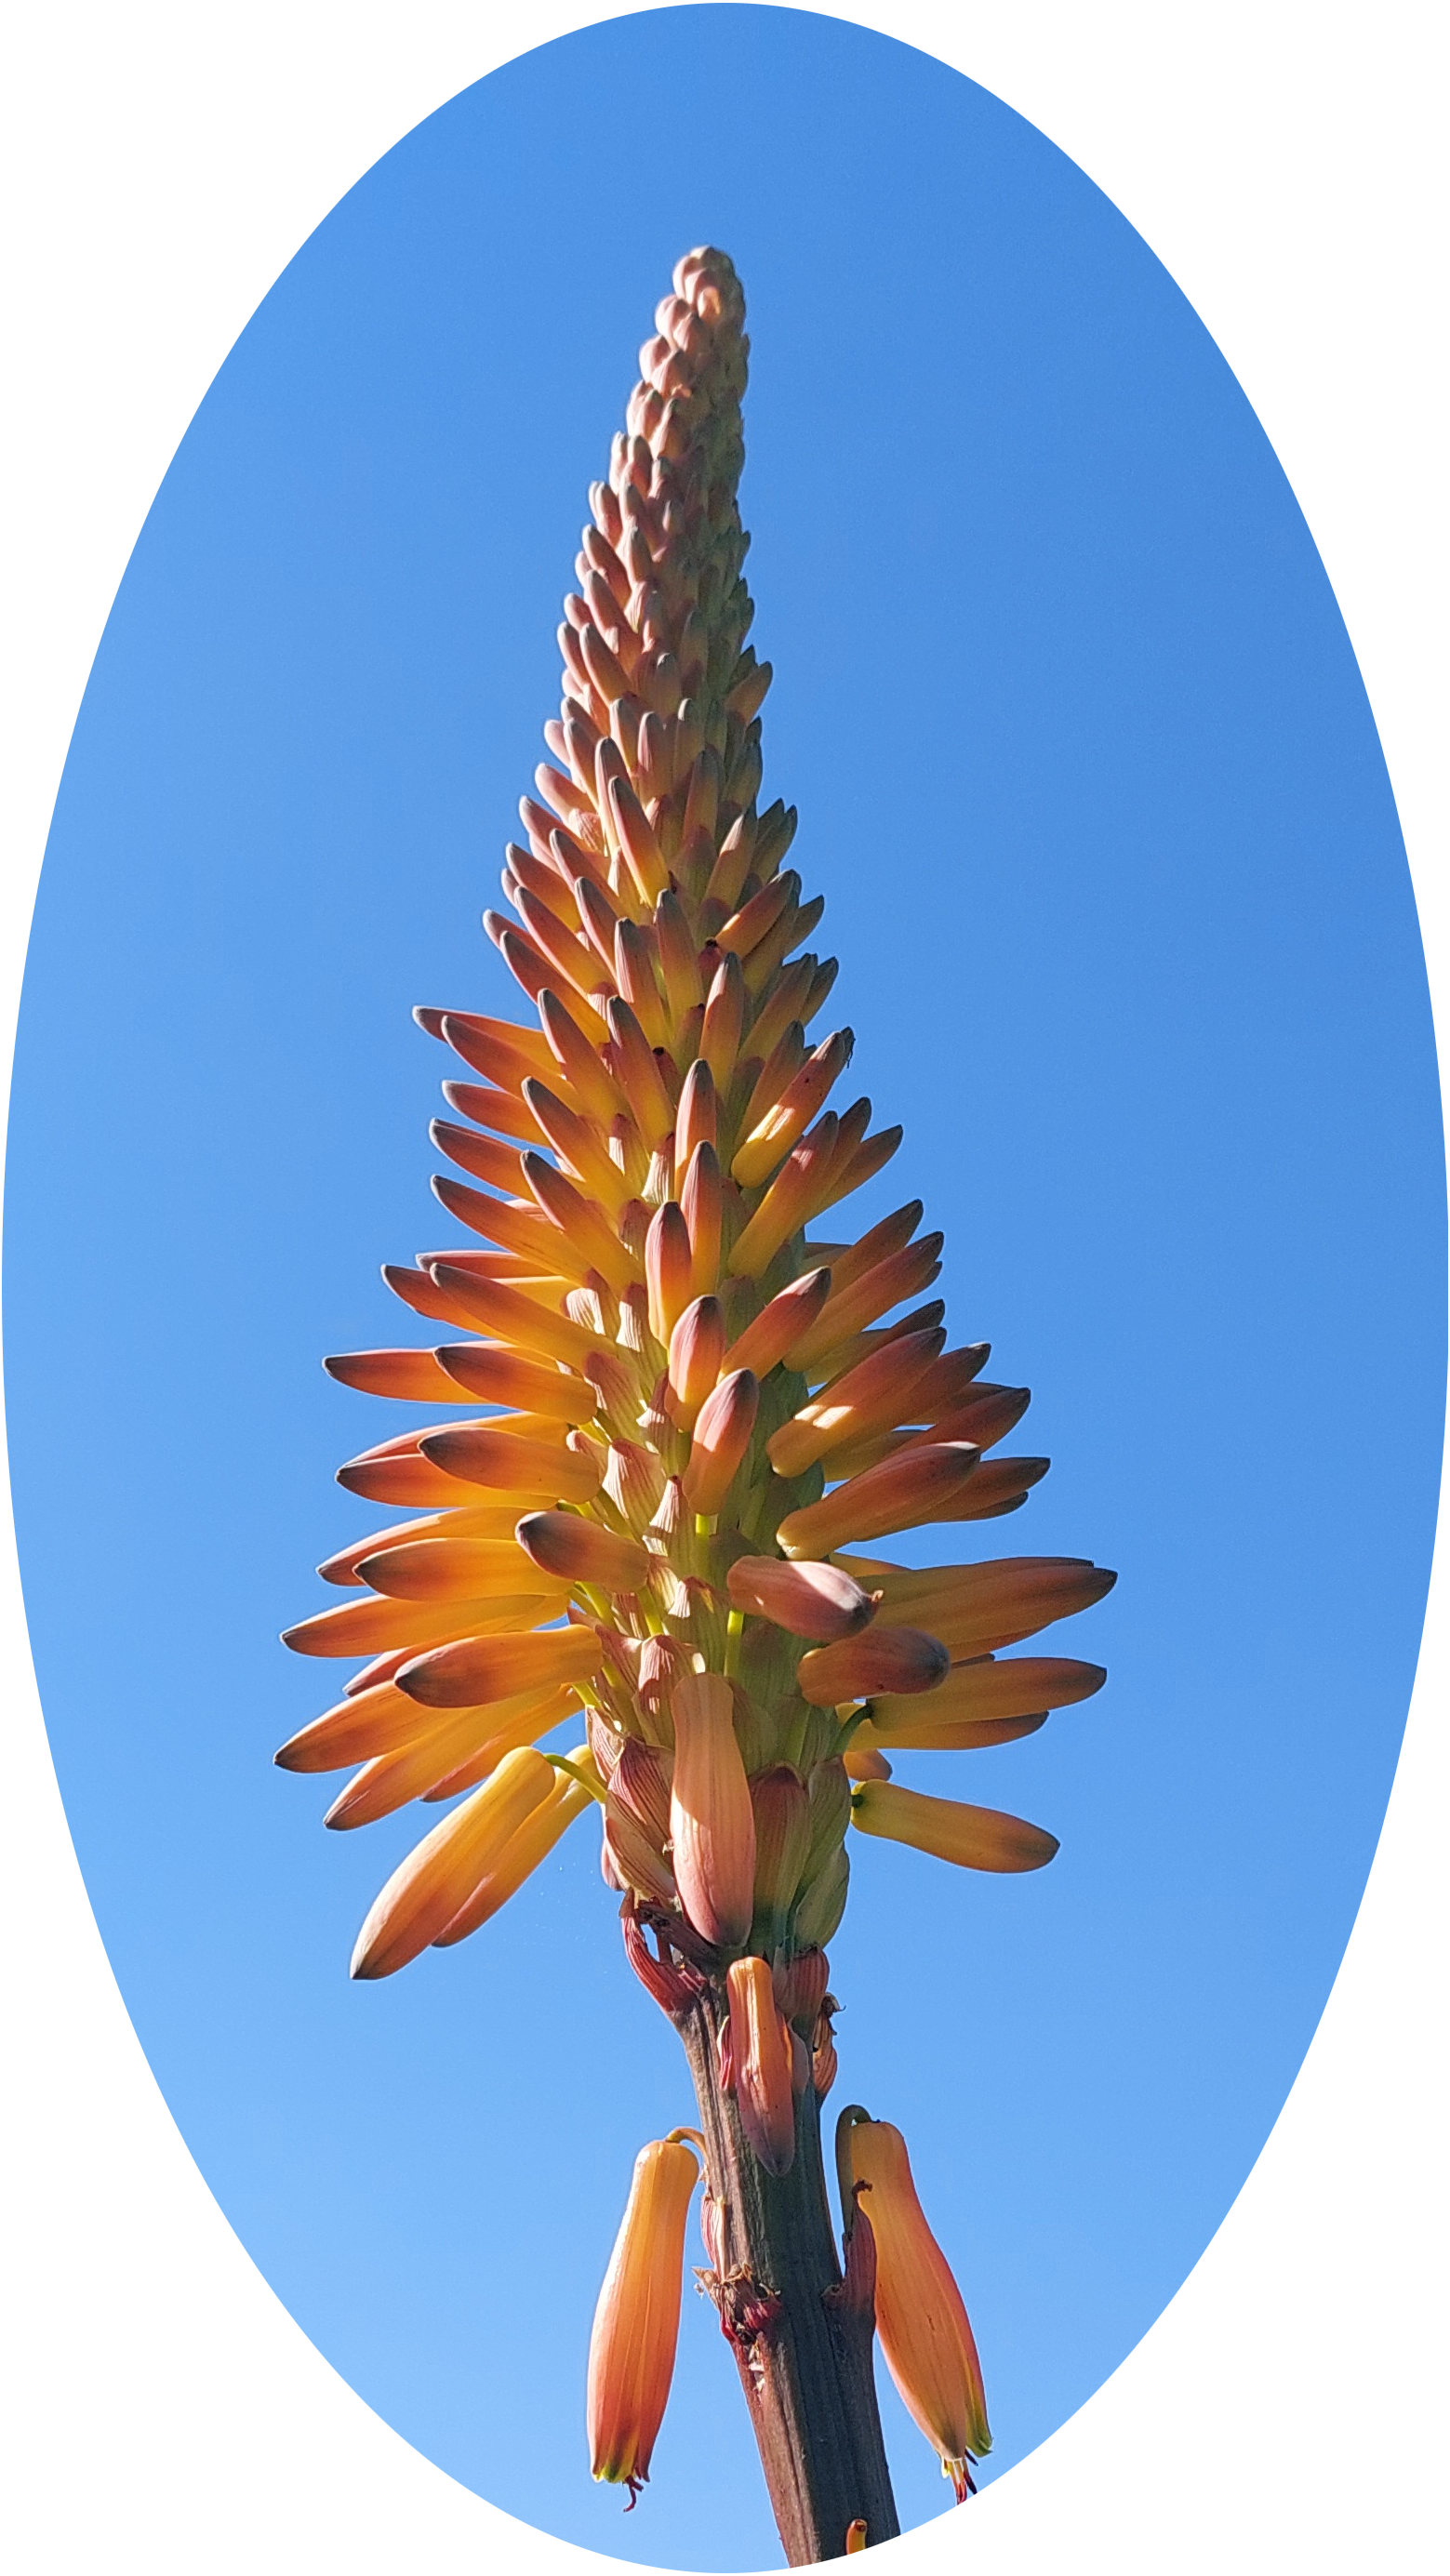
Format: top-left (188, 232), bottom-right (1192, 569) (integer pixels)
top-left (670, 1672), bottom-right (754, 1950)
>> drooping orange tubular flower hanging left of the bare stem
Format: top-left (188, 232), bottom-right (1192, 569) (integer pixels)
top-left (587, 2138), bottom-right (700, 2496)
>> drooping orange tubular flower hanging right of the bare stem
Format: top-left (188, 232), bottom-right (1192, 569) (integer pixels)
top-left (850, 2120), bottom-right (991, 2502)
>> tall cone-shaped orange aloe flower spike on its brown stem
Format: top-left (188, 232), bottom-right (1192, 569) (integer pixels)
top-left (278, 250), bottom-right (1112, 2563)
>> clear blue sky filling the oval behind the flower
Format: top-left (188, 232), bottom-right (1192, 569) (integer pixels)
top-left (10, 7), bottom-right (1443, 2569)
